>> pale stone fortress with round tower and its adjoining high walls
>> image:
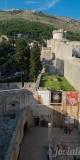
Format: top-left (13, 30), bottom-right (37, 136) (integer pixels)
top-left (41, 29), bottom-right (80, 92)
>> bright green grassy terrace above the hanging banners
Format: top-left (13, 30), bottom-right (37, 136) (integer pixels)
top-left (40, 75), bottom-right (75, 91)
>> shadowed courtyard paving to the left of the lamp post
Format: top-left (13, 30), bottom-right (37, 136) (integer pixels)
top-left (19, 127), bottom-right (48, 160)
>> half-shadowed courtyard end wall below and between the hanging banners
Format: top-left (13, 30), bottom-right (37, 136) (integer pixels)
top-left (33, 90), bottom-right (80, 130)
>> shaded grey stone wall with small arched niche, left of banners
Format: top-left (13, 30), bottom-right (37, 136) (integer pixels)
top-left (0, 89), bottom-right (37, 114)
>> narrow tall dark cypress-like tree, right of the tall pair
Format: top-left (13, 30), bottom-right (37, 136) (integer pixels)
top-left (29, 42), bottom-right (42, 82)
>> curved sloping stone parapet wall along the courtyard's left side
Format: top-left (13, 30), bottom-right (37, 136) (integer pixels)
top-left (4, 107), bottom-right (33, 160)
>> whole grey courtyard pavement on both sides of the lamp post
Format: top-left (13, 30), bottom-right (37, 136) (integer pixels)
top-left (18, 127), bottom-right (80, 160)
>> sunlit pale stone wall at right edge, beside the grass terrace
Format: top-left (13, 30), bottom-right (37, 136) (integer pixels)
top-left (64, 57), bottom-right (80, 92)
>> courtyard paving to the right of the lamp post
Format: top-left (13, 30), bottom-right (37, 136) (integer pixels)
top-left (52, 128), bottom-right (80, 160)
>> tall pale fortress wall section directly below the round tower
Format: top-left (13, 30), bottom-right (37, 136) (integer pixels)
top-left (51, 40), bottom-right (72, 75)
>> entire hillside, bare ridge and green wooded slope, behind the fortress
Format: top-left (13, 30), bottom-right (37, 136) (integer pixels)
top-left (0, 10), bottom-right (80, 44)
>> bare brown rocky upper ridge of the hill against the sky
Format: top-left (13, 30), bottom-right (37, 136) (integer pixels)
top-left (0, 9), bottom-right (80, 32)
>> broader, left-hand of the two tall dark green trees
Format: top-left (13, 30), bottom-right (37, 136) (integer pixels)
top-left (14, 39), bottom-right (30, 71)
